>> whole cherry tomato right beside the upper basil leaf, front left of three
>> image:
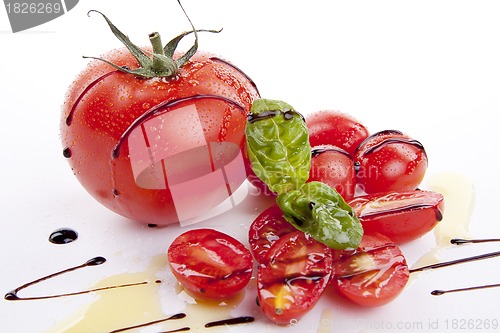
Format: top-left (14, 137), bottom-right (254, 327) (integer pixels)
top-left (308, 145), bottom-right (356, 200)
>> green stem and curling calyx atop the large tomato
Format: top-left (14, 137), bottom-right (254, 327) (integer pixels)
top-left (84, 1), bottom-right (221, 79)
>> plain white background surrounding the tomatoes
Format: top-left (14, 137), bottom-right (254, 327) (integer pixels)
top-left (0, 0), bottom-right (500, 332)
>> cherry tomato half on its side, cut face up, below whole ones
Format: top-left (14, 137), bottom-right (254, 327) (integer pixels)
top-left (348, 190), bottom-right (444, 243)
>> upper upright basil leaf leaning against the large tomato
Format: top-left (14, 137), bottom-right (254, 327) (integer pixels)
top-left (245, 99), bottom-right (311, 194)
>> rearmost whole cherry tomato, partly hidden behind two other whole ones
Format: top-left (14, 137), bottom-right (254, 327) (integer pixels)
top-left (306, 110), bottom-right (368, 156)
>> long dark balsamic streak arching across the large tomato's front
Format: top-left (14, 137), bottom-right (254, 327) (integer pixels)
top-left (111, 94), bottom-right (245, 159)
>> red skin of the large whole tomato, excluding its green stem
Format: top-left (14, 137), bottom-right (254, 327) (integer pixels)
top-left (61, 50), bottom-right (258, 225)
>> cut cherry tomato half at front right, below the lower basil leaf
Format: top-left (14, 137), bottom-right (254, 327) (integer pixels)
top-left (332, 234), bottom-right (410, 307)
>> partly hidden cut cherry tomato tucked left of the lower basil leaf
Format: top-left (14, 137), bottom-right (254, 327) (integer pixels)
top-left (248, 204), bottom-right (297, 264)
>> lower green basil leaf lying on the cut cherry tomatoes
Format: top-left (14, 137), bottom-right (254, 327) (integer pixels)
top-left (276, 182), bottom-right (363, 250)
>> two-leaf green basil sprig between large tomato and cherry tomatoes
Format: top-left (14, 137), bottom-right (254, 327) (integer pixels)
top-left (245, 99), bottom-right (363, 250)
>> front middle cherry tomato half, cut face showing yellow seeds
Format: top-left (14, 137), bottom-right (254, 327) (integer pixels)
top-left (257, 231), bottom-right (333, 325)
